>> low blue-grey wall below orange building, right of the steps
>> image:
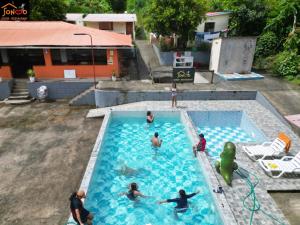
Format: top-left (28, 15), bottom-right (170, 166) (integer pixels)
top-left (28, 81), bottom-right (94, 100)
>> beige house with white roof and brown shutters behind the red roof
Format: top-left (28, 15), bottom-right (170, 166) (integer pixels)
top-left (83, 13), bottom-right (137, 40)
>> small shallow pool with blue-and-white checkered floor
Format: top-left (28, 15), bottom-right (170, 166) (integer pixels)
top-left (188, 111), bottom-right (267, 158)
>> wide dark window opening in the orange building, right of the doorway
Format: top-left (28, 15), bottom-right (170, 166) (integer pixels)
top-left (51, 49), bottom-right (107, 65)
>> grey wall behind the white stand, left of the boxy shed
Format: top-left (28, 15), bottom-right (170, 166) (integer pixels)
top-left (152, 45), bottom-right (210, 66)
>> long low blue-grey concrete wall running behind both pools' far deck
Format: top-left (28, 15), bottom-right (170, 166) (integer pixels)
top-left (95, 90), bottom-right (256, 107)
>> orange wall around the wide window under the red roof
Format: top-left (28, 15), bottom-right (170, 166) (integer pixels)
top-left (33, 49), bottom-right (119, 79)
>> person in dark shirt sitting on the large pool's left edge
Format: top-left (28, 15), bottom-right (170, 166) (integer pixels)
top-left (70, 190), bottom-right (93, 225)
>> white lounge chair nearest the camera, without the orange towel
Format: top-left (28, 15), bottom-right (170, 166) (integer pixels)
top-left (258, 152), bottom-right (300, 178)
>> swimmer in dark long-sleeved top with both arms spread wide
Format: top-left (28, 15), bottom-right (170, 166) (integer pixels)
top-left (158, 189), bottom-right (200, 216)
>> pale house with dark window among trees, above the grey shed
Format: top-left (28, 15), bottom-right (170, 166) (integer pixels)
top-left (196, 12), bottom-right (230, 32)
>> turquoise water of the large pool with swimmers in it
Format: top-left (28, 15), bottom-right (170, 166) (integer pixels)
top-left (85, 113), bottom-right (222, 225)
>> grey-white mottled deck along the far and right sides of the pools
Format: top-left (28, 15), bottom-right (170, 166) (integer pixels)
top-left (84, 100), bottom-right (300, 224)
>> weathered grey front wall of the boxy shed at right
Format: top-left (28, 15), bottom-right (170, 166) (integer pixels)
top-left (211, 37), bottom-right (256, 74)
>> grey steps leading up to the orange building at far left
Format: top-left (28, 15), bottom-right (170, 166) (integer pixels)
top-left (4, 79), bottom-right (33, 105)
